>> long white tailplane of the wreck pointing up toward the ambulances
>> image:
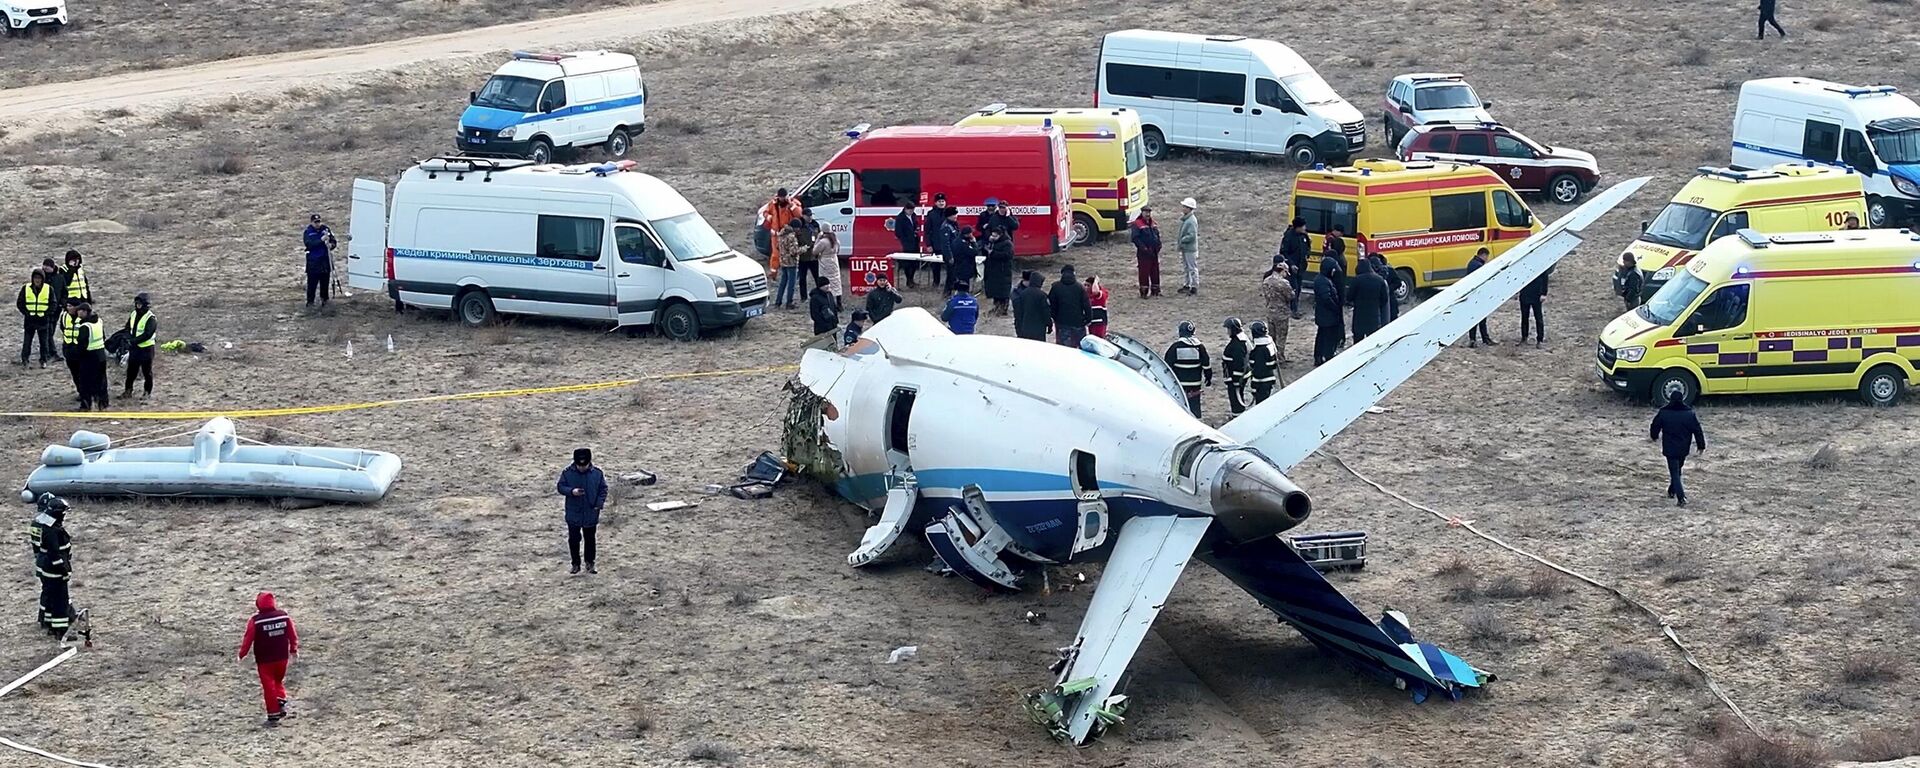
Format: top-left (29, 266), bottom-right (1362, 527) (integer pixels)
top-left (1221, 177), bottom-right (1647, 470)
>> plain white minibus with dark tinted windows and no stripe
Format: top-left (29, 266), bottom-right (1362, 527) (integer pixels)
top-left (1094, 29), bottom-right (1367, 167)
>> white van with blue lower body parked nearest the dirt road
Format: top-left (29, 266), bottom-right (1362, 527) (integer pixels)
top-left (455, 50), bottom-right (647, 165)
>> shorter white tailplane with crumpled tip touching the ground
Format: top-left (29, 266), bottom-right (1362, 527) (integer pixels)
top-left (1054, 516), bottom-right (1213, 743)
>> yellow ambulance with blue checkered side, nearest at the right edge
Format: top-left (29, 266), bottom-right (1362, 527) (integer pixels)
top-left (1599, 228), bottom-right (1920, 405)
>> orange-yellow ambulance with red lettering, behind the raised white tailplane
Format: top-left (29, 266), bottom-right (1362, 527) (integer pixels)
top-left (1288, 159), bottom-right (1540, 300)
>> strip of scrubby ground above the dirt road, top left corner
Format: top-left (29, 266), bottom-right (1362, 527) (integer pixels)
top-left (0, 0), bottom-right (647, 88)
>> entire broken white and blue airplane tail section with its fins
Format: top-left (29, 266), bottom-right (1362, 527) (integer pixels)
top-left (787, 180), bottom-right (1640, 743)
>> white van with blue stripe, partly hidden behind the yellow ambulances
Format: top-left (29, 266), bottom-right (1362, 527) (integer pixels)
top-left (1734, 77), bottom-right (1920, 228)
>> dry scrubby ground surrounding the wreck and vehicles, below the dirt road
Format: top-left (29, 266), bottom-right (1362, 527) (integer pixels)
top-left (0, 0), bottom-right (1920, 766)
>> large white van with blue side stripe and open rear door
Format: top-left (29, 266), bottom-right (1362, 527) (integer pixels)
top-left (348, 157), bottom-right (766, 342)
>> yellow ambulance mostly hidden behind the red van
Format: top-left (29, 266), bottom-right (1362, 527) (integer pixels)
top-left (954, 104), bottom-right (1148, 246)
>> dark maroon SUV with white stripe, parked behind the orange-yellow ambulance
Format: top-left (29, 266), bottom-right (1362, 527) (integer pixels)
top-left (1400, 123), bottom-right (1599, 204)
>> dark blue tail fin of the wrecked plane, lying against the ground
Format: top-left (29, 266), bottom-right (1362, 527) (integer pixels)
top-left (1200, 536), bottom-right (1494, 701)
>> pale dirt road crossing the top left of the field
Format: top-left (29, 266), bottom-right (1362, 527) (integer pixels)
top-left (0, 0), bottom-right (860, 138)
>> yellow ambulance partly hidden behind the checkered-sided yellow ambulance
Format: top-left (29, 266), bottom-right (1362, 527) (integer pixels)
top-left (1626, 163), bottom-right (1866, 301)
